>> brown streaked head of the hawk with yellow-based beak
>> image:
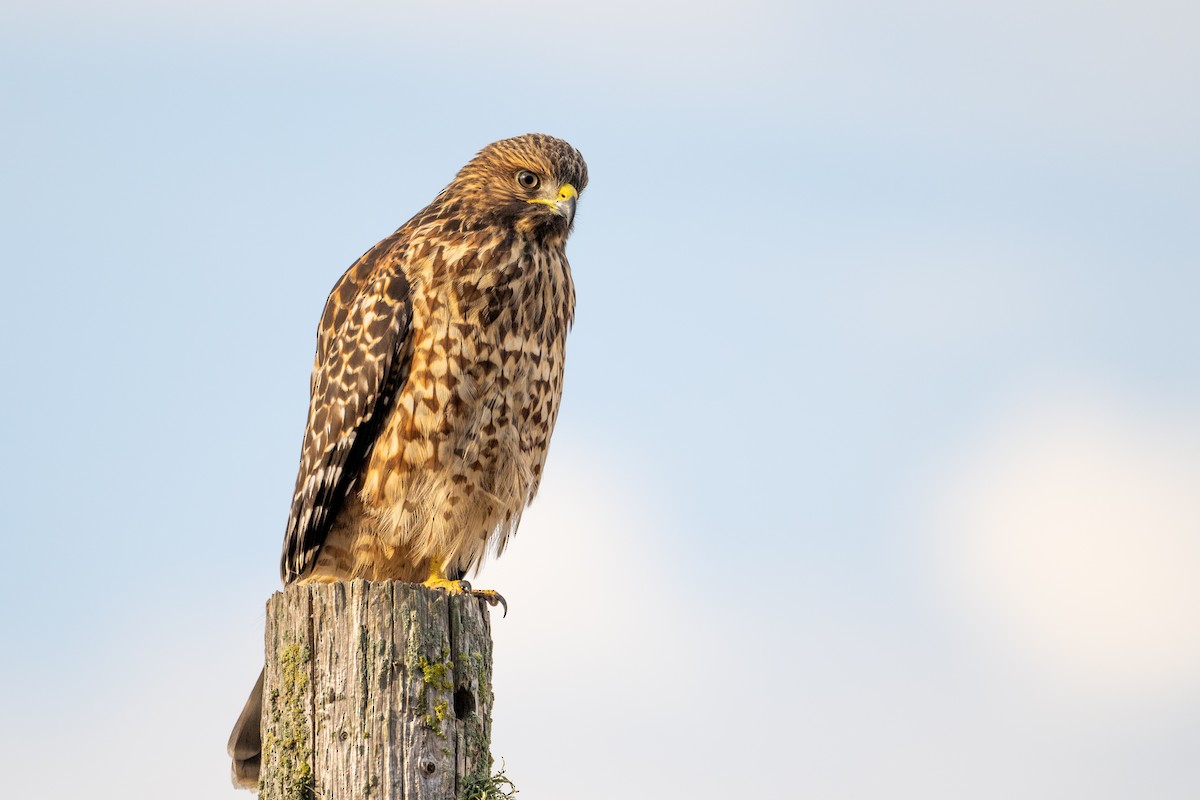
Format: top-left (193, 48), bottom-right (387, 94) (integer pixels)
top-left (443, 133), bottom-right (588, 239)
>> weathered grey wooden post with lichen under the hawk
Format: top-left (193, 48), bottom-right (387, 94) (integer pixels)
top-left (259, 581), bottom-right (492, 800)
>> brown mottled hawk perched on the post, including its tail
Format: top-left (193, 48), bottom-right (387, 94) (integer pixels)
top-left (229, 133), bottom-right (588, 788)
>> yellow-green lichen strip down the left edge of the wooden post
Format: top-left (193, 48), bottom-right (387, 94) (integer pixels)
top-left (258, 644), bottom-right (314, 800)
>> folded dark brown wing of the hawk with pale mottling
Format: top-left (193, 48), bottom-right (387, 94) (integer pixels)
top-left (280, 240), bottom-right (412, 583)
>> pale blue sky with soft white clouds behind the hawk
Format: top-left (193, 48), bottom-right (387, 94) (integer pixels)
top-left (0, 0), bottom-right (1200, 800)
